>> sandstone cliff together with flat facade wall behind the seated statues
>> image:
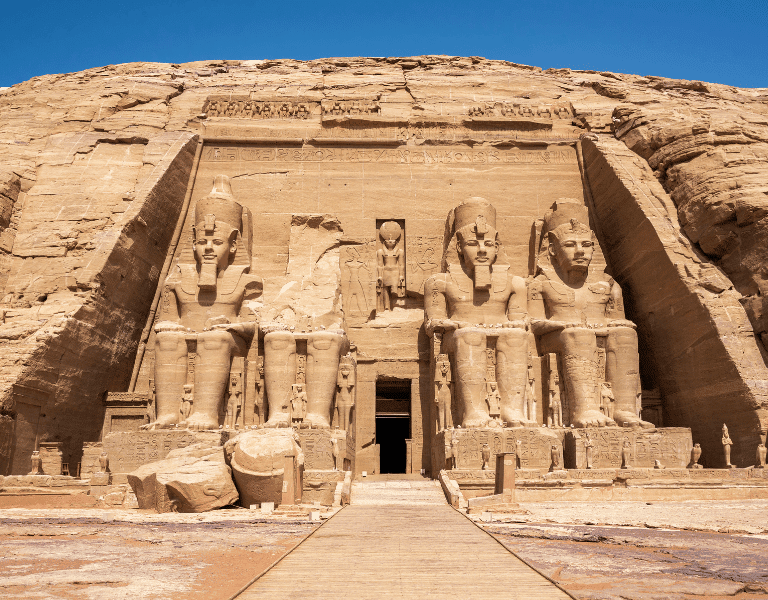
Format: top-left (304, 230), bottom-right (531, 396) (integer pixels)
top-left (0, 56), bottom-right (768, 474)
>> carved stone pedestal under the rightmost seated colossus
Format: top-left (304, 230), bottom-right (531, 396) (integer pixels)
top-left (563, 427), bottom-right (693, 469)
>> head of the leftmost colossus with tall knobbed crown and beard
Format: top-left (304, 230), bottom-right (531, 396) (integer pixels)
top-left (192, 175), bottom-right (243, 289)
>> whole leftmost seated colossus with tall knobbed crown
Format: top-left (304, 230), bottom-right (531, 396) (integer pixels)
top-left (145, 175), bottom-right (262, 429)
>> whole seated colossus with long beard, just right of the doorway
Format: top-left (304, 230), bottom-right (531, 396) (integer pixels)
top-left (424, 198), bottom-right (533, 427)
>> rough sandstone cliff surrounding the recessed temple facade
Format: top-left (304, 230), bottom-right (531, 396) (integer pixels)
top-left (0, 56), bottom-right (768, 471)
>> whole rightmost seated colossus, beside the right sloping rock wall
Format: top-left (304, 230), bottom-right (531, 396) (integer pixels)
top-left (528, 200), bottom-right (653, 428)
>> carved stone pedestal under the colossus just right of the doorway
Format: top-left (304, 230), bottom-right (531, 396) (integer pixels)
top-left (434, 427), bottom-right (566, 473)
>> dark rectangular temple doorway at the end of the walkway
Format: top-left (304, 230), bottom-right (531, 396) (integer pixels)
top-left (376, 379), bottom-right (411, 473)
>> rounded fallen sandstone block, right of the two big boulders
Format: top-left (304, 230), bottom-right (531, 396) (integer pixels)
top-left (227, 429), bottom-right (304, 507)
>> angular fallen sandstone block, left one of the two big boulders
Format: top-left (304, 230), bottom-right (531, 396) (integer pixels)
top-left (128, 444), bottom-right (238, 513)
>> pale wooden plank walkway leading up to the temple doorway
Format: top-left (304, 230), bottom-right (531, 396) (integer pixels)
top-left (238, 481), bottom-right (569, 600)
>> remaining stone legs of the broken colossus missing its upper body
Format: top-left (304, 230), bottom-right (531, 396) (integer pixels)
top-left (264, 326), bottom-right (349, 429)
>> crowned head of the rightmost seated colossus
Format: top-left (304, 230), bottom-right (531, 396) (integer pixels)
top-left (544, 201), bottom-right (595, 277)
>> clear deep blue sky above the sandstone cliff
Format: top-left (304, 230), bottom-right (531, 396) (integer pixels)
top-left (0, 0), bottom-right (768, 87)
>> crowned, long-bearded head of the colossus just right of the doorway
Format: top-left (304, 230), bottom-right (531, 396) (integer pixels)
top-left (454, 198), bottom-right (499, 289)
